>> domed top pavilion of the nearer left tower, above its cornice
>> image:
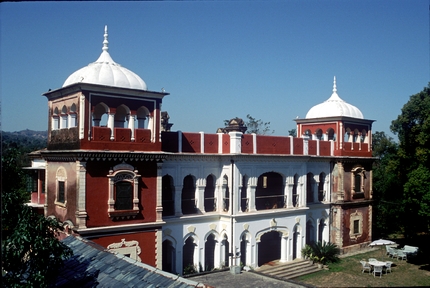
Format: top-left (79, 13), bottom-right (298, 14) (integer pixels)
top-left (43, 27), bottom-right (168, 151)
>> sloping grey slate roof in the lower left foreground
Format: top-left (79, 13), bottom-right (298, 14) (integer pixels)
top-left (51, 236), bottom-right (205, 288)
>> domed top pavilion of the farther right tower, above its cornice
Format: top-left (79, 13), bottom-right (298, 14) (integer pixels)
top-left (295, 77), bottom-right (374, 157)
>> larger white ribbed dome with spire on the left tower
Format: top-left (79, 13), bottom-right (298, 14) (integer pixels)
top-left (63, 27), bottom-right (147, 90)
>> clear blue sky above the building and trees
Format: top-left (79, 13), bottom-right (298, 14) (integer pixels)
top-left (0, 0), bottom-right (430, 135)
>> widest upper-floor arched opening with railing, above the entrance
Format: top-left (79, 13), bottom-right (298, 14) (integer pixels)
top-left (255, 172), bottom-right (284, 210)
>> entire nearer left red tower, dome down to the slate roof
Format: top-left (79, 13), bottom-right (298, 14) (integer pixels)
top-left (41, 27), bottom-right (168, 268)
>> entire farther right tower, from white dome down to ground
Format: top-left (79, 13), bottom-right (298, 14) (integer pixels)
top-left (295, 77), bottom-right (374, 252)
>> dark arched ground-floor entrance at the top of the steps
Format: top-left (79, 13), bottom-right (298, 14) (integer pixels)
top-left (258, 231), bottom-right (282, 266)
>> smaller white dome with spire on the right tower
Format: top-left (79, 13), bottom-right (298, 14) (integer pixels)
top-left (306, 77), bottom-right (364, 119)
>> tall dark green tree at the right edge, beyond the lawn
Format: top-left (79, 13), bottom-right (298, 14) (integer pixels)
top-left (390, 83), bottom-right (430, 237)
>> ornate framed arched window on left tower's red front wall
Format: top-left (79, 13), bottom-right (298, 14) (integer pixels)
top-left (107, 163), bottom-right (140, 218)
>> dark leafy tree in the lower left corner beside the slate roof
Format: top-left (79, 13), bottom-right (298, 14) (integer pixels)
top-left (1, 148), bottom-right (72, 287)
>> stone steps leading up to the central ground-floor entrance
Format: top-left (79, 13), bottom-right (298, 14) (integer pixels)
top-left (255, 259), bottom-right (321, 280)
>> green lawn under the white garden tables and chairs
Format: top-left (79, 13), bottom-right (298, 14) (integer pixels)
top-left (294, 247), bottom-right (430, 287)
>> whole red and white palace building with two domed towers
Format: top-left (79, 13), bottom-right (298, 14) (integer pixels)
top-left (28, 29), bottom-right (373, 274)
